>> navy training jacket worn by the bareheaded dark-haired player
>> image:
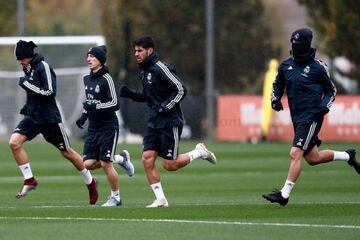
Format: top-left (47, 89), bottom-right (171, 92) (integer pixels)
top-left (126, 52), bottom-right (186, 129)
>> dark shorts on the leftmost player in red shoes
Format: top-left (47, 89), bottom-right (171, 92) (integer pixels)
top-left (13, 117), bottom-right (71, 151)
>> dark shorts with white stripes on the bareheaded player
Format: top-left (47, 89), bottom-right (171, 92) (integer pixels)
top-left (143, 126), bottom-right (182, 160)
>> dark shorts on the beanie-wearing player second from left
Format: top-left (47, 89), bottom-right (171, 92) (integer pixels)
top-left (83, 128), bottom-right (119, 162)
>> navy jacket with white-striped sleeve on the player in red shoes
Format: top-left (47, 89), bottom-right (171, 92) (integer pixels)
top-left (19, 53), bottom-right (61, 124)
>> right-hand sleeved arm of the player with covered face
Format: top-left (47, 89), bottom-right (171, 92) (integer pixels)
top-left (320, 61), bottom-right (337, 115)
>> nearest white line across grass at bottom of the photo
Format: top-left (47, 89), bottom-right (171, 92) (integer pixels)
top-left (0, 217), bottom-right (360, 229)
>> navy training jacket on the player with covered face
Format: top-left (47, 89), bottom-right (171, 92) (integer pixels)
top-left (271, 49), bottom-right (336, 123)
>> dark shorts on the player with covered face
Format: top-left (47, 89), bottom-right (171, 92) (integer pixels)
top-left (293, 120), bottom-right (322, 156)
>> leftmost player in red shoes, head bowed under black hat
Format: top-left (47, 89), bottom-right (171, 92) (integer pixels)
top-left (9, 40), bottom-right (98, 204)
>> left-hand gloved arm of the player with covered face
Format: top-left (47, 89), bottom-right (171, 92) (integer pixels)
top-left (271, 65), bottom-right (285, 111)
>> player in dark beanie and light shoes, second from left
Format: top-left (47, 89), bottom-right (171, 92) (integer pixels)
top-left (76, 45), bottom-right (134, 207)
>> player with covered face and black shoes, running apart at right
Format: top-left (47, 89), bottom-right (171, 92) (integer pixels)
top-left (263, 28), bottom-right (360, 206)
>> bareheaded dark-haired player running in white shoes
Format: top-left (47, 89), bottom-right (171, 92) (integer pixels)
top-left (120, 36), bottom-right (216, 208)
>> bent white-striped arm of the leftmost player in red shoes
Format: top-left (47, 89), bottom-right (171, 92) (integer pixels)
top-left (19, 61), bottom-right (56, 97)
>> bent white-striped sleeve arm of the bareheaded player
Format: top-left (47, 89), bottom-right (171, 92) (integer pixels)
top-left (156, 61), bottom-right (186, 112)
